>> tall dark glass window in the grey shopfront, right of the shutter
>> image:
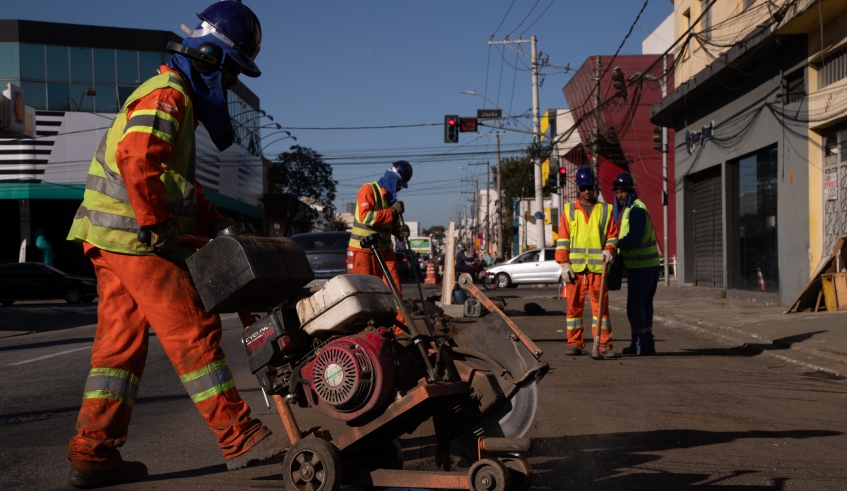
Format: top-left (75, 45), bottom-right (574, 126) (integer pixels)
top-left (730, 146), bottom-right (779, 292)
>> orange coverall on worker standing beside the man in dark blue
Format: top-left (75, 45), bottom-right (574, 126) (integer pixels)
top-left (556, 200), bottom-right (619, 351)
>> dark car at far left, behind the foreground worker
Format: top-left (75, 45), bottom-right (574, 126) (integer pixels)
top-left (0, 263), bottom-right (97, 305)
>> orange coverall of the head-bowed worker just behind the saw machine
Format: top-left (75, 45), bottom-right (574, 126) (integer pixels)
top-left (347, 183), bottom-right (403, 334)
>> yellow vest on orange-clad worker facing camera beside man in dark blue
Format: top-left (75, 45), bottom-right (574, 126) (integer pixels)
top-left (556, 201), bottom-right (618, 273)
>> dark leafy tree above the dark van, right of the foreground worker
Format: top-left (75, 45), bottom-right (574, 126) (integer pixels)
top-left (268, 145), bottom-right (338, 228)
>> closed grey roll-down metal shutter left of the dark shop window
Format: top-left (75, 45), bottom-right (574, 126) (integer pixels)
top-left (694, 172), bottom-right (724, 288)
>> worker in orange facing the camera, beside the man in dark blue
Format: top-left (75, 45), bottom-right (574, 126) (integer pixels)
top-left (556, 167), bottom-right (620, 359)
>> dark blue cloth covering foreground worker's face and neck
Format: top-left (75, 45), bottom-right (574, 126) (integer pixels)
top-left (168, 38), bottom-right (235, 152)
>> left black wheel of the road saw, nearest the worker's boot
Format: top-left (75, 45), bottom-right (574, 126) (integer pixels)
top-left (282, 438), bottom-right (341, 491)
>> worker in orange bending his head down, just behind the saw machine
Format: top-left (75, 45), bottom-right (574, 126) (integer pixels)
top-left (347, 160), bottom-right (412, 334)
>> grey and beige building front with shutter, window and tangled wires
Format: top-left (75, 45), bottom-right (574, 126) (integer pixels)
top-left (651, 0), bottom-right (847, 305)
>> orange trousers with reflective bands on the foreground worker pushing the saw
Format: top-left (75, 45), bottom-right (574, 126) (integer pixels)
top-left (68, 248), bottom-right (270, 470)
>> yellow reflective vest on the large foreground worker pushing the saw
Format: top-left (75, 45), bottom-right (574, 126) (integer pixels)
top-left (68, 72), bottom-right (197, 260)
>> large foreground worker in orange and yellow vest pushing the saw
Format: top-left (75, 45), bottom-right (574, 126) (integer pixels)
top-left (67, 2), bottom-right (287, 488)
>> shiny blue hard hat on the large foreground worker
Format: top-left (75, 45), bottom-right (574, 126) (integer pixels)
top-left (183, 0), bottom-right (262, 77)
